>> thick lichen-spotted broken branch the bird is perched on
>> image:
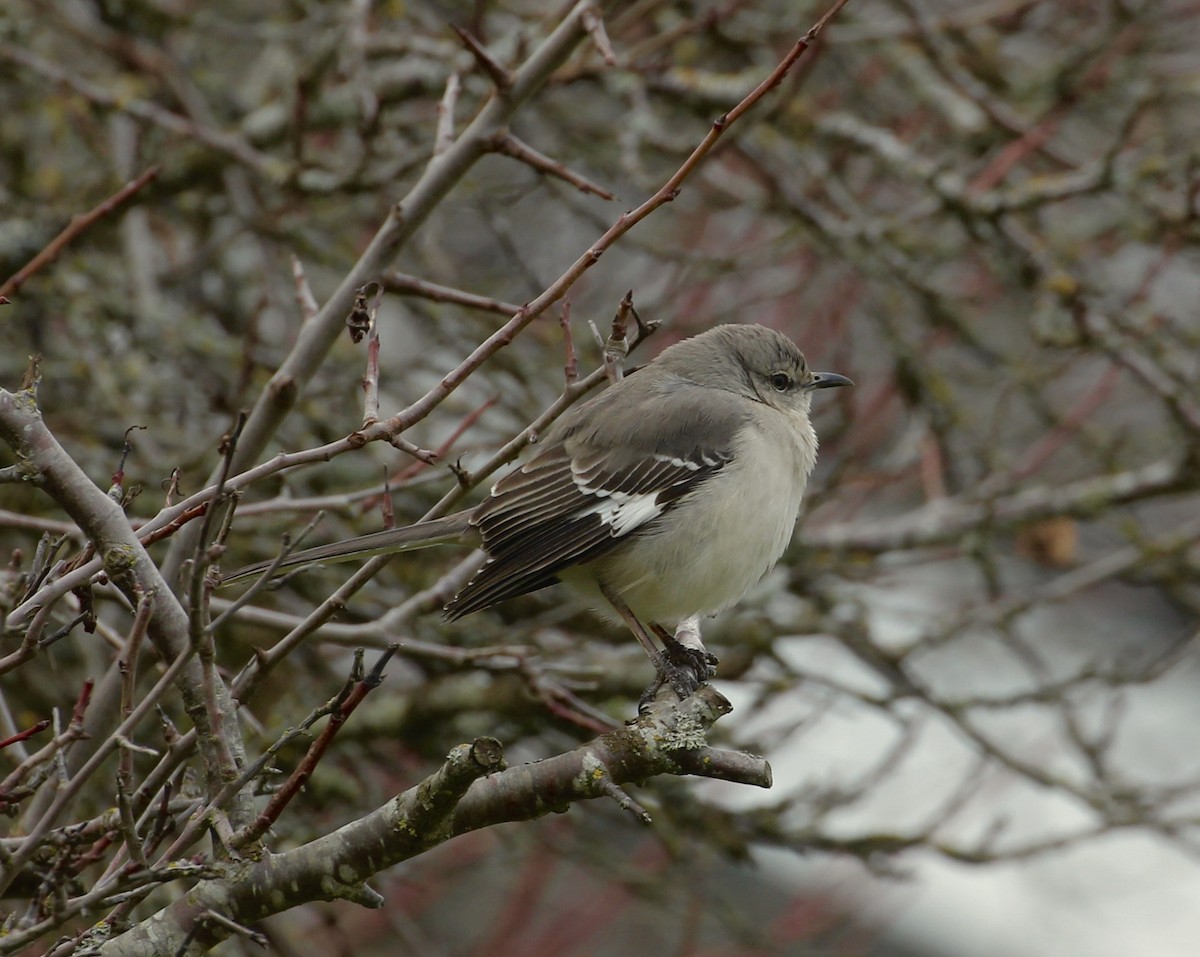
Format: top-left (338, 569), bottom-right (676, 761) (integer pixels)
top-left (100, 686), bottom-right (769, 957)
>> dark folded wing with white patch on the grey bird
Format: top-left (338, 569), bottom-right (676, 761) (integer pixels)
top-left (445, 396), bottom-right (737, 619)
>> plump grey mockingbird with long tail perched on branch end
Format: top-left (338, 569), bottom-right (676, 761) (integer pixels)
top-left (227, 325), bottom-right (852, 700)
